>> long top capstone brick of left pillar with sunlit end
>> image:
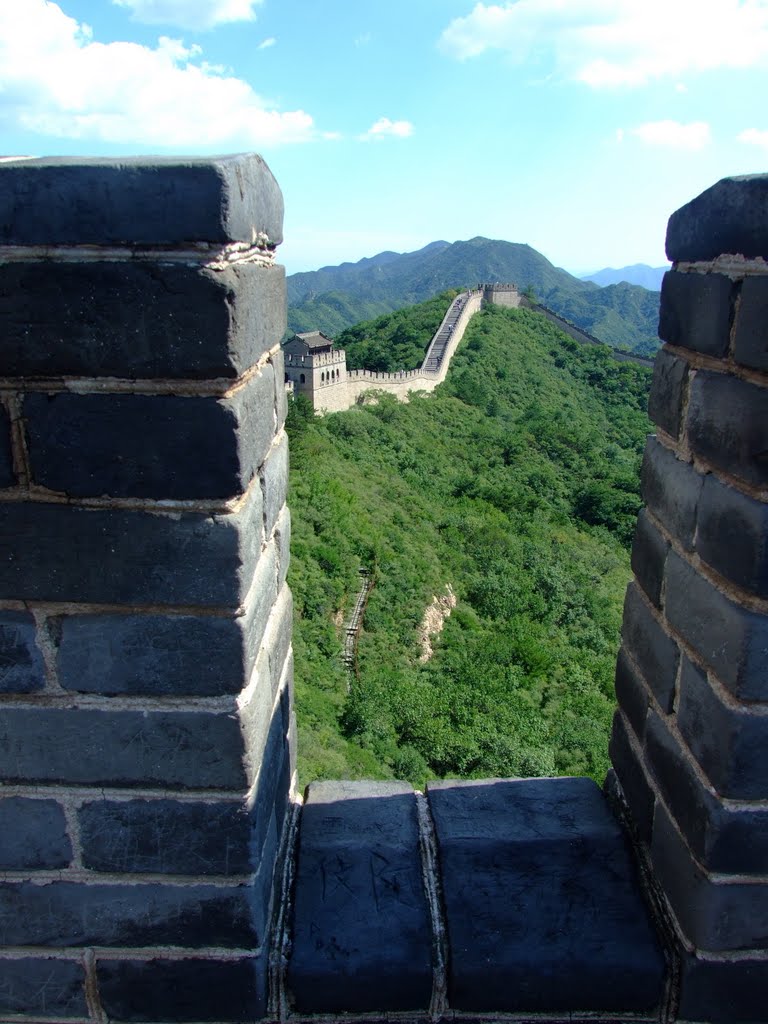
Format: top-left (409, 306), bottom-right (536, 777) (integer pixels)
top-left (0, 154), bottom-right (283, 246)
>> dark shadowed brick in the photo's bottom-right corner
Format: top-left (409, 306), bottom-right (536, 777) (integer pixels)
top-left (678, 953), bottom-right (768, 1024)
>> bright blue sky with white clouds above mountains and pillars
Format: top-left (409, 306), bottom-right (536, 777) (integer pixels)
top-left (0, 0), bottom-right (768, 272)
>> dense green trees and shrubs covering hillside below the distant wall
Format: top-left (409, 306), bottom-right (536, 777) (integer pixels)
top-left (289, 301), bottom-right (650, 783)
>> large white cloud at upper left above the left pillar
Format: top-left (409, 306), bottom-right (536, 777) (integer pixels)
top-left (0, 0), bottom-right (316, 152)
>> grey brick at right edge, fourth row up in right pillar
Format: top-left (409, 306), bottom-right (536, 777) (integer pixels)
top-left (678, 658), bottom-right (768, 800)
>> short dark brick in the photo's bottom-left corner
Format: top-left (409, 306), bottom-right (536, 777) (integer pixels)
top-left (0, 956), bottom-right (88, 1021)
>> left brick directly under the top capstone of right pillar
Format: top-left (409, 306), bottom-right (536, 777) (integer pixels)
top-left (654, 270), bottom-right (733, 356)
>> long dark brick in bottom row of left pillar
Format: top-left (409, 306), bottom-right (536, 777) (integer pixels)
top-left (96, 955), bottom-right (266, 1024)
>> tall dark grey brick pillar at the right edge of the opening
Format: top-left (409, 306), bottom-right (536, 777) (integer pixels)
top-left (610, 175), bottom-right (768, 1021)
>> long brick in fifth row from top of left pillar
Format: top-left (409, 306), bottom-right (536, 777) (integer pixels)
top-left (55, 614), bottom-right (251, 696)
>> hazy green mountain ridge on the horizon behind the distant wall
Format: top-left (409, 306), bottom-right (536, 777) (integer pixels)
top-left (288, 238), bottom-right (659, 354)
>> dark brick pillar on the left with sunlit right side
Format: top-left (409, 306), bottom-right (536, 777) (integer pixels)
top-left (0, 157), bottom-right (294, 1021)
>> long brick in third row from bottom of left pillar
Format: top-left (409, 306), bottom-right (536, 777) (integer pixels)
top-left (78, 800), bottom-right (252, 874)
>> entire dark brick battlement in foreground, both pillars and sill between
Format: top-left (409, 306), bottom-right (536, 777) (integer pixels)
top-left (0, 156), bottom-right (768, 1024)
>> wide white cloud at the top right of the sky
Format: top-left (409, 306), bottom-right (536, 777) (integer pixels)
top-left (439, 0), bottom-right (768, 88)
